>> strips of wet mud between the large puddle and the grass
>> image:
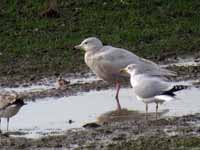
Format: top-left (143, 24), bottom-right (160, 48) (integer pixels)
top-left (0, 61), bottom-right (200, 101)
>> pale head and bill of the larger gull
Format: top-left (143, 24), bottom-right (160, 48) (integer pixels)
top-left (75, 37), bottom-right (103, 52)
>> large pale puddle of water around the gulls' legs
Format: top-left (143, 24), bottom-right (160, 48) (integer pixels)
top-left (2, 88), bottom-right (200, 138)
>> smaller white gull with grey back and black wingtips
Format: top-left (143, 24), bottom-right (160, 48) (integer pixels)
top-left (121, 64), bottom-right (188, 118)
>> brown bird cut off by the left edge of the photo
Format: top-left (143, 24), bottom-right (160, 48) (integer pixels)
top-left (0, 92), bottom-right (25, 132)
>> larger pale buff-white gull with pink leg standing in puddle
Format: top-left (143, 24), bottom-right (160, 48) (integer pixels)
top-left (75, 37), bottom-right (174, 110)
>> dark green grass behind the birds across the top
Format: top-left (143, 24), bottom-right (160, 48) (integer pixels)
top-left (0, 0), bottom-right (200, 75)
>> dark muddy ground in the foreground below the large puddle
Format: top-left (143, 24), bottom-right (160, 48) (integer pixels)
top-left (0, 114), bottom-right (200, 150)
